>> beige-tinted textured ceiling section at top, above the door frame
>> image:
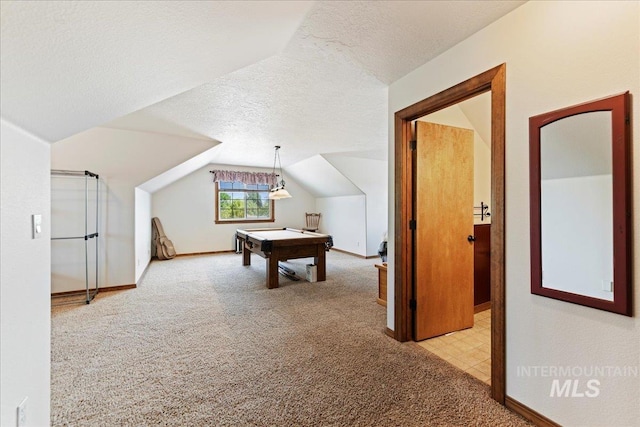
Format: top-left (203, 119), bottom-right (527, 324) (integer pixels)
top-left (287, 0), bottom-right (524, 85)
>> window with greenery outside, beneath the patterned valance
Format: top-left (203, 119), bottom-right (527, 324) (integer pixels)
top-left (216, 181), bottom-right (274, 223)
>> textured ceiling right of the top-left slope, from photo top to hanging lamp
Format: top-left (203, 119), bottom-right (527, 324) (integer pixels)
top-left (107, 1), bottom-right (523, 168)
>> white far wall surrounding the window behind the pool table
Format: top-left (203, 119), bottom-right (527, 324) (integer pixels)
top-left (151, 165), bottom-right (316, 254)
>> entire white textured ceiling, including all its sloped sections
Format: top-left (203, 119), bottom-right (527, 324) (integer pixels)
top-left (0, 1), bottom-right (524, 167)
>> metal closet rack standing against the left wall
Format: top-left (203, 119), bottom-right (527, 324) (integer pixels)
top-left (51, 169), bottom-right (100, 306)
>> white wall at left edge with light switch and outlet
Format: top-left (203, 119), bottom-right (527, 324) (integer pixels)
top-left (0, 120), bottom-right (51, 426)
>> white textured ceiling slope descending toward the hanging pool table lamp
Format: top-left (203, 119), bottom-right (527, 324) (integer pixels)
top-left (106, 55), bottom-right (387, 171)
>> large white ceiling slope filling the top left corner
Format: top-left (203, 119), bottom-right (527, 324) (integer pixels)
top-left (0, 0), bottom-right (312, 142)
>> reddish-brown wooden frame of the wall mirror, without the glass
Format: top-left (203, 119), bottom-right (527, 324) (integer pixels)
top-left (529, 92), bottom-right (632, 316)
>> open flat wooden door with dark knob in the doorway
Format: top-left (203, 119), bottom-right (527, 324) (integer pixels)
top-left (414, 121), bottom-right (473, 340)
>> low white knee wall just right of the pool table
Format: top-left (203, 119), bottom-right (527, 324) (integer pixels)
top-left (316, 195), bottom-right (364, 256)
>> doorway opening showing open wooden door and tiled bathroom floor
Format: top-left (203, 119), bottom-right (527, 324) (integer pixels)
top-left (412, 92), bottom-right (491, 384)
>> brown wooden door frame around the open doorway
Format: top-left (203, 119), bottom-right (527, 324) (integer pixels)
top-left (393, 64), bottom-right (506, 405)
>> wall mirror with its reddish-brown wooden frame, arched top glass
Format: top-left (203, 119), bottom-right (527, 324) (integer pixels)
top-left (529, 92), bottom-right (632, 316)
